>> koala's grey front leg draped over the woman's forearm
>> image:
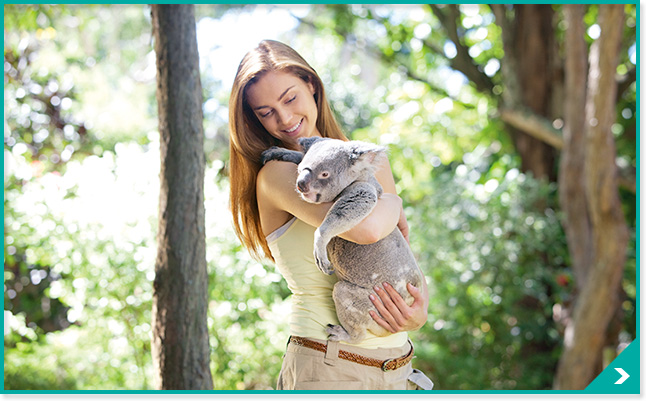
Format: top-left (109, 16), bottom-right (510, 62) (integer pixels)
top-left (314, 182), bottom-right (378, 275)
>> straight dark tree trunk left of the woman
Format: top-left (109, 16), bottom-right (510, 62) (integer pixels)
top-left (152, 5), bottom-right (213, 390)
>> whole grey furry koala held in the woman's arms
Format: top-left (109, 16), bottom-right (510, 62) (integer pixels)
top-left (262, 137), bottom-right (423, 343)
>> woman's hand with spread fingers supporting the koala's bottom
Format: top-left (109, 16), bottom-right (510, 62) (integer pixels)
top-left (370, 280), bottom-right (428, 334)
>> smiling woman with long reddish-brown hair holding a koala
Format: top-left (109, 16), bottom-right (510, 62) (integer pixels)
top-left (229, 41), bottom-right (430, 389)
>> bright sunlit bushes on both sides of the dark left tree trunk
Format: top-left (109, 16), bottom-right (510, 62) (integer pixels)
top-left (5, 143), bottom-right (289, 389)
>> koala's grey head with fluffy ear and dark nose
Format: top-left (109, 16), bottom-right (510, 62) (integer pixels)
top-left (296, 137), bottom-right (386, 204)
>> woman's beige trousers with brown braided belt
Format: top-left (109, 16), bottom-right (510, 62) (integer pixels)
top-left (276, 339), bottom-right (433, 390)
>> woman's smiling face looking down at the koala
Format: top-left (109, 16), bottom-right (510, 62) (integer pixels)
top-left (247, 71), bottom-right (321, 149)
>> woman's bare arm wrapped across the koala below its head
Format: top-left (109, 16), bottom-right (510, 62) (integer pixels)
top-left (256, 161), bottom-right (402, 244)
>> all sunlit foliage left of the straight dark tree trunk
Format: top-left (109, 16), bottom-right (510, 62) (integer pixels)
top-left (4, 5), bottom-right (158, 389)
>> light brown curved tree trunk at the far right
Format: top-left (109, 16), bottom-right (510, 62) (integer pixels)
top-left (554, 5), bottom-right (628, 389)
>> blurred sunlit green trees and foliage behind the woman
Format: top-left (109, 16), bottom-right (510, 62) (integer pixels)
top-left (4, 5), bottom-right (637, 390)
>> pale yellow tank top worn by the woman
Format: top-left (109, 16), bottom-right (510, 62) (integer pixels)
top-left (267, 218), bottom-right (408, 349)
